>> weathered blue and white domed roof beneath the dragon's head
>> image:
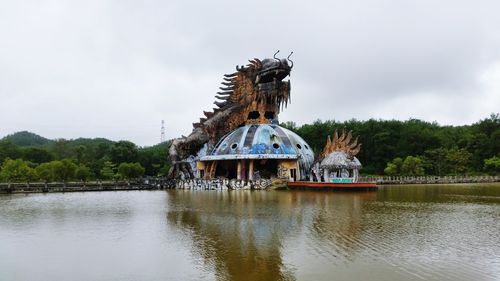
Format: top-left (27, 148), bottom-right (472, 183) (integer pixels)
top-left (201, 124), bottom-right (314, 165)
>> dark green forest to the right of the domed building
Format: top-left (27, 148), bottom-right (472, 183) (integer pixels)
top-left (281, 114), bottom-right (500, 175)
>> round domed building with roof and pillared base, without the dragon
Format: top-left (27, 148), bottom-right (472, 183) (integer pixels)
top-left (197, 124), bottom-right (314, 181)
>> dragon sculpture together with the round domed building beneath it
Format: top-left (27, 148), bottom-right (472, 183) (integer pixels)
top-left (169, 51), bottom-right (314, 179)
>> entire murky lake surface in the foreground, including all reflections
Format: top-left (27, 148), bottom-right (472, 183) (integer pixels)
top-left (0, 184), bottom-right (500, 281)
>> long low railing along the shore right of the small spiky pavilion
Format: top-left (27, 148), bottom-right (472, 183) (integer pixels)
top-left (359, 176), bottom-right (500, 184)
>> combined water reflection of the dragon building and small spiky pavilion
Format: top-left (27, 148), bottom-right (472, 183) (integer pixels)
top-left (167, 191), bottom-right (376, 280)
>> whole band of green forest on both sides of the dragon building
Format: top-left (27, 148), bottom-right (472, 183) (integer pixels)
top-left (0, 114), bottom-right (500, 182)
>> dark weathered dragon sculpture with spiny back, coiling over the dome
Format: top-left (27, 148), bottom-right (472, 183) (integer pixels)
top-left (169, 50), bottom-right (293, 178)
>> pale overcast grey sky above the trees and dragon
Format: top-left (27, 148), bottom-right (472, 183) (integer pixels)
top-left (0, 0), bottom-right (500, 146)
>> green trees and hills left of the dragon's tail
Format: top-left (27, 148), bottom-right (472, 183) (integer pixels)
top-left (0, 132), bottom-right (169, 182)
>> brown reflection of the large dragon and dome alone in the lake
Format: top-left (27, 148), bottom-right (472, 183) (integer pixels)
top-left (167, 191), bottom-right (300, 280)
